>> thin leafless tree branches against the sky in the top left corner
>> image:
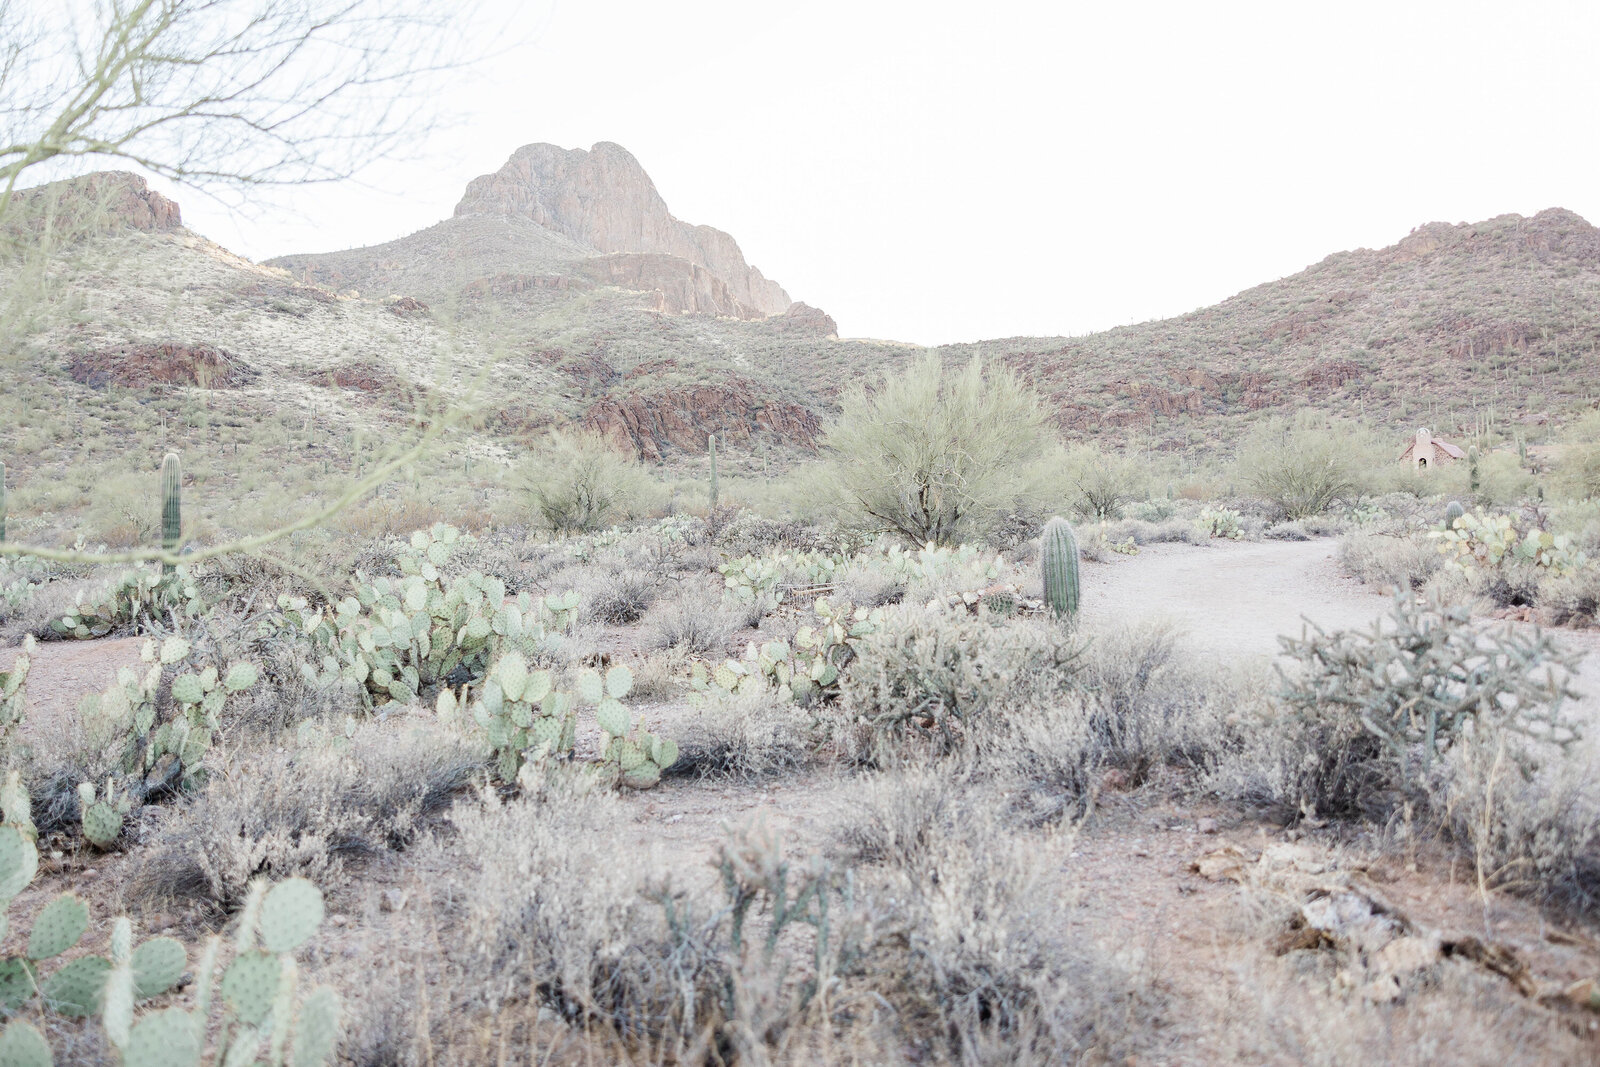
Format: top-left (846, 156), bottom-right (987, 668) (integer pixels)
top-left (0, 0), bottom-right (472, 214)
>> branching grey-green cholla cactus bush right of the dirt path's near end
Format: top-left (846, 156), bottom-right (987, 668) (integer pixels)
top-left (1245, 590), bottom-right (1576, 819)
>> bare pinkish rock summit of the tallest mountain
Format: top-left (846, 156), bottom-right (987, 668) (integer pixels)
top-left (456, 141), bottom-right (790, 315)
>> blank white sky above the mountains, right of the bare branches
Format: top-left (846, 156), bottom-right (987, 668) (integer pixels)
top-left (165, 0), bottom-right (1600, 344)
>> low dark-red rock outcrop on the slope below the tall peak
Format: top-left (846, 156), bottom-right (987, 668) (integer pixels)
top-left (582, 378), bottom-right (822, 461)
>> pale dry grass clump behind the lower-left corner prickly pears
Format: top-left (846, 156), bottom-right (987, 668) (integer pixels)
top-left (130, 720), bottom-right (483, 912)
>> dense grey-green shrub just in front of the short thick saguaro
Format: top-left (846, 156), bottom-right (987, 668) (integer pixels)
top-left (842, 608), bottom-right (1082, 755)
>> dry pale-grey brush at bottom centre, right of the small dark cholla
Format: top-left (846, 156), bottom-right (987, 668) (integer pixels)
top-left (842, 780), bottom-right (1162, 1065)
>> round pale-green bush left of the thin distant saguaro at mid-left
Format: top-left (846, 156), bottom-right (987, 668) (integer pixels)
top-left (531, 432), bottom-right (646, 533)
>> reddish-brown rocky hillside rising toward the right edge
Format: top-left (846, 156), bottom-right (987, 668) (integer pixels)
top-left (947, 208), bottom-right (1600, 450)
